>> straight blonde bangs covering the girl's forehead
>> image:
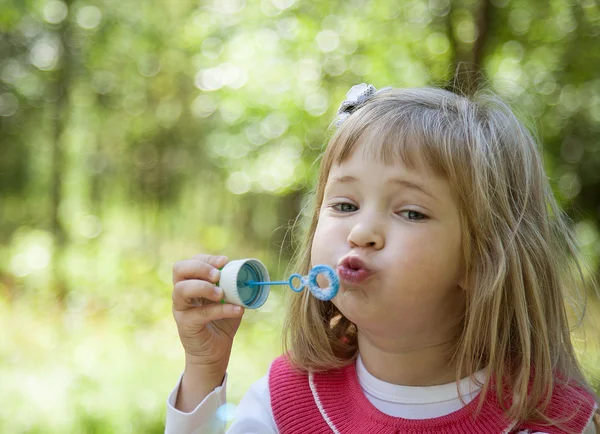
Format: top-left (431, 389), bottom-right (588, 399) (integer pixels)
top-left (320, 102), bottom-right (464, 202)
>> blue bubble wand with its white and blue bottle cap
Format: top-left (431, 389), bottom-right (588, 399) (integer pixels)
top-left (219, 259), bottom-right (340, 309)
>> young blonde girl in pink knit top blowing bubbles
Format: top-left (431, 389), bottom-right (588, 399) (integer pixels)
top-left (166, 84), bottom-right (600, 434)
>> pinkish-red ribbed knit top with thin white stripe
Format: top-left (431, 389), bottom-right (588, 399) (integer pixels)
top-left (269, 356), bottom-right (595, 434)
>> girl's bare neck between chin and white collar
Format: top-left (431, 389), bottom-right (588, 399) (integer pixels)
top-left (358, 330), bottom-right (468, 386)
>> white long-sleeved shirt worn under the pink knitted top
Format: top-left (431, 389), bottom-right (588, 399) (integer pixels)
top-left (165, 356), bottom-right (594, 434)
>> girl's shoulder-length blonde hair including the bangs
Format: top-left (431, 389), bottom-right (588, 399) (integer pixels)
top-left (283, 88), bottom-right (598, 424)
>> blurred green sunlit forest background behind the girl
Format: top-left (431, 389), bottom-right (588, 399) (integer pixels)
top-left (0, 0), bottom-right (600, 433)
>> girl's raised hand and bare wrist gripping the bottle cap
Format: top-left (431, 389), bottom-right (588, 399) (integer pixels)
top-left (173, 255), bottom-right (244, 406)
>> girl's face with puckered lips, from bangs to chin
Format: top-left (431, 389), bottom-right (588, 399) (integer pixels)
top-left (311, 146), bottom-right (465, 345)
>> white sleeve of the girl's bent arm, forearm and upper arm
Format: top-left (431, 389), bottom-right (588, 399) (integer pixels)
top-left (165, 374), bottom-right (278, 434)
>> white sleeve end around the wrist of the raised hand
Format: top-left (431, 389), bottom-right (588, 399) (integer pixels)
top-left (165, 374), bottom-right (227, 434)
